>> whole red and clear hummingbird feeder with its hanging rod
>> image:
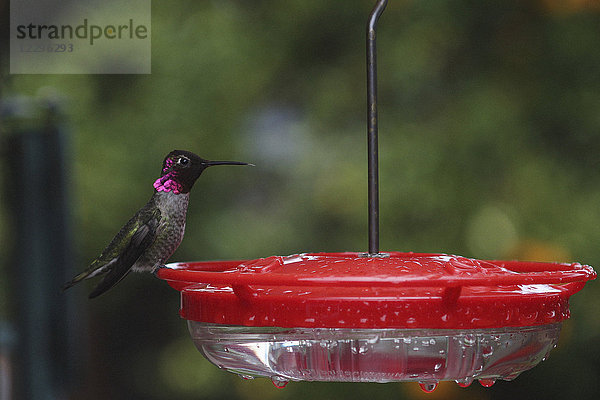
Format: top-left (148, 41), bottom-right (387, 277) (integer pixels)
top-left (157, 0), bottom-right (596, 392)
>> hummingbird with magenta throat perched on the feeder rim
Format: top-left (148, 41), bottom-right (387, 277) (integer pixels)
top-left (63, 150), bottom-right (252, 299)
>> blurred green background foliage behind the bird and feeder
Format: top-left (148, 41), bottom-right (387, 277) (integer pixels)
top-left (0, 0), bottom-right (600, 400)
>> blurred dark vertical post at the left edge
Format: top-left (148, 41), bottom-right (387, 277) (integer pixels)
top-left (0, 97), bottom-right (77, 400)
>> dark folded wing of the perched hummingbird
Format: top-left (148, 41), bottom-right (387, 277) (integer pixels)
top-left (89, 209), bottom-right (160, 299)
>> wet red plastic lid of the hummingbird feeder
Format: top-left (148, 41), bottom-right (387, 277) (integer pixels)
top-left (158, 252), bottom-right (596, 329)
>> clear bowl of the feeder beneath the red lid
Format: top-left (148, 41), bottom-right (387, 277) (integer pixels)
top-left (188, 321), bottom-right (561, 390)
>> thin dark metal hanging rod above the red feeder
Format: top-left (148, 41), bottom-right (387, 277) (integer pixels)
top-left (367, 0), bottom-right (387, 255)
